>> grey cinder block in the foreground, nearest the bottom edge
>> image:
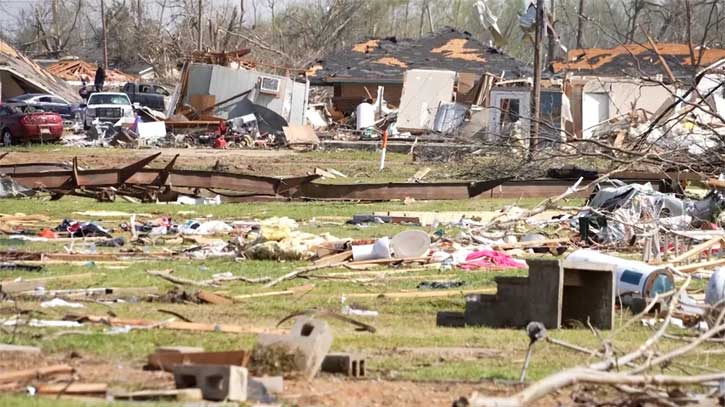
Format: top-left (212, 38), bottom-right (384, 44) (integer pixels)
top-left (174, 365), bottom-right (248, 401)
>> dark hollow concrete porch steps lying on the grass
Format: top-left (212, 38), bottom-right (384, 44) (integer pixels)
top-left (437, 260), bottom-right (615, 329)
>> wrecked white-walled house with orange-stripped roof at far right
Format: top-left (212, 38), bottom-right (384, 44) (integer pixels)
top-left (549, 43), bottom-right (725, 138)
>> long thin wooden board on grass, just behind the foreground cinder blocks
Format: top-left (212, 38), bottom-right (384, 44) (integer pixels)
top-left (74, 315), bottom-right (279, 334)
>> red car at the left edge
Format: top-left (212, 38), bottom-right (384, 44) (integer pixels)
top-left (0, 104), bottom-right (63, 146)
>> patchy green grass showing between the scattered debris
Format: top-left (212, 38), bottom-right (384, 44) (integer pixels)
top-left (0, 147), bottom-right (725, 407)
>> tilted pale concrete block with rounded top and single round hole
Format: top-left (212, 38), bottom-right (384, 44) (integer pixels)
top-left (252, 317), bottom-right (332, 380)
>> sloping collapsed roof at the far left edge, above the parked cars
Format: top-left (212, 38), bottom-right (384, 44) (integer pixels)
top-left (0, 40), bottom-right (79, 101)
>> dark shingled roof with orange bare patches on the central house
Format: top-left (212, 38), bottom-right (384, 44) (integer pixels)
top-left (307, 27), bottom-right (533, 85)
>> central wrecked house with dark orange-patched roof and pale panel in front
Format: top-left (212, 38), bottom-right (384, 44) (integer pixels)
top-left (307, 27), bottom-right (532, 138)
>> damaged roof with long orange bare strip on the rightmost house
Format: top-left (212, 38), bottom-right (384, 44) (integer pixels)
top-left (550, 43), bottom-right (725, 79)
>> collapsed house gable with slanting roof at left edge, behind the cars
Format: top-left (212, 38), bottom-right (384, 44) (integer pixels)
top-left (0, 40), bottom-right (78, 102)
